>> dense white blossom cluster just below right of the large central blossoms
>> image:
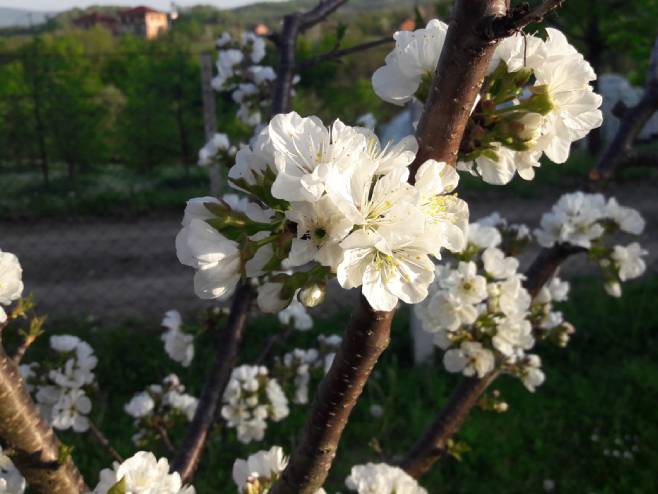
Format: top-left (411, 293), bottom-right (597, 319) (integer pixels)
top-left (416, 214), bottom-right (573, 391)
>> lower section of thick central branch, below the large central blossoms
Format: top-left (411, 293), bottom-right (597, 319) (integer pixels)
top-left (270, 296), bottom-right (394, 494)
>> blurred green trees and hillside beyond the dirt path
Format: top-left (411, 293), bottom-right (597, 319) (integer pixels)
top-left (0, 0), bottom-right (658, 217)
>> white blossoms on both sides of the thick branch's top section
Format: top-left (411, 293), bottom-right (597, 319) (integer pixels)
top-left (372, 19), bottom-right (602, 184)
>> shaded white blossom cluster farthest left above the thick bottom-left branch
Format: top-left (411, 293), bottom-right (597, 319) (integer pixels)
top-left (20, 335), bottom-right (98, 432)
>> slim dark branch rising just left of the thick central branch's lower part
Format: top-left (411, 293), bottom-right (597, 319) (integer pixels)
top-left (172, 282), bottom-right (254, 483)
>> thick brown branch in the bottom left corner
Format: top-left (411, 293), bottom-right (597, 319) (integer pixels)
top-left (0, 345), bottom-right (88, 494)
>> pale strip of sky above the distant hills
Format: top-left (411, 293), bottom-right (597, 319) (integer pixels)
top-left (0, 0), bottom-right (276, 11)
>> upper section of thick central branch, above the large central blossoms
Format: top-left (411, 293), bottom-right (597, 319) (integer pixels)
top-left (411, 0), bottom-right (507, 176)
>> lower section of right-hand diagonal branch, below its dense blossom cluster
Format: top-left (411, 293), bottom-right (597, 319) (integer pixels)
top-left (400, 372), bottom-right (498, 478)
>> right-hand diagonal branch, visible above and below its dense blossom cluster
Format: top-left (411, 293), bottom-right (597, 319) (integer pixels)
top-left (401, 245), bottom-right (585, 478)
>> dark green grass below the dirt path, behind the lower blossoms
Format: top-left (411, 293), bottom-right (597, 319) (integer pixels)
top-left (8, 277), bottom-right (658, 494)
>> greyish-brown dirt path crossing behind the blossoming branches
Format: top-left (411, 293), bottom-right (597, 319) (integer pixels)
top-left (0, 183), bottom-right (658, 321)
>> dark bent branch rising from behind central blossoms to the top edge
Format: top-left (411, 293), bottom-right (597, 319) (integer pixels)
top-left (272, 0), bottom-right (347, 116)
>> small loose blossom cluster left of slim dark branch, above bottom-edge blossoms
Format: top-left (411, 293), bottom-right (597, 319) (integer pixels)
top-left (123, 374), bottom-right (199, 446)
